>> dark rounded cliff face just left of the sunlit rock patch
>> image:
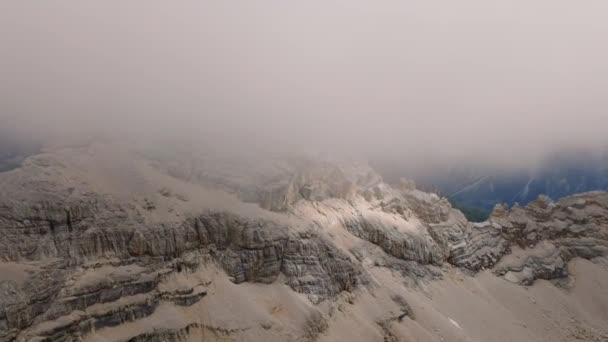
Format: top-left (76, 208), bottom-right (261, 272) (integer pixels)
top-left (194, 214), bottom-right (365, 301)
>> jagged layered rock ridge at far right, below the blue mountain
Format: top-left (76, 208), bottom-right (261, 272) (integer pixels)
top-left (450, 192), bottom-right (608, 285)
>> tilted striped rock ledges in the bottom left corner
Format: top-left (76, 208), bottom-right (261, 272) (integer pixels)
top-left (0, 254), bottom-right (206, 341)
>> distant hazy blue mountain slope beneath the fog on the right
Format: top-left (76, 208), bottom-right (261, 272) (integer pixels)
top-left (380, 150), bottom-right (608, 221)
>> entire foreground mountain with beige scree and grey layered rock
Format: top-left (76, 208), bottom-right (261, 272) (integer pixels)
top-left (0, 143), bottom-right (608, 342)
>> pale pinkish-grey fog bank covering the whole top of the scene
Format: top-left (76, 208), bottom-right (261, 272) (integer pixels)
top-left (0, 0), bottom-right (608, 170)
